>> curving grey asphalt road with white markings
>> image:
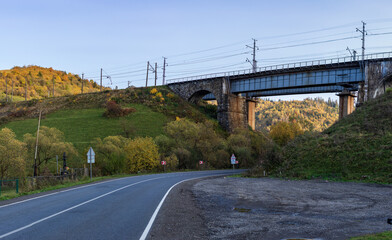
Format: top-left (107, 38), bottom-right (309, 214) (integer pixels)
top-left (0, 170), bottom-right (241, 239)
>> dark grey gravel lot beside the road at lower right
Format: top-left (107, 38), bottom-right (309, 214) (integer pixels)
top-left (150, 177), bottom-right (392, 240)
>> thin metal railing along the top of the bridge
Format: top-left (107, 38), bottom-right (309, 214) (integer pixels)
top-left (166, 52), bottom-right (392, 84)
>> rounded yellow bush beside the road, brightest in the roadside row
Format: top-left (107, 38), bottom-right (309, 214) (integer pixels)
top-left (124, 137), bottom-right (159, 173)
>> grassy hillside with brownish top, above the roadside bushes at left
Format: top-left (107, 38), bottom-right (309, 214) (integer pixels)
top-left (0, 87), bottom-right (214, 152)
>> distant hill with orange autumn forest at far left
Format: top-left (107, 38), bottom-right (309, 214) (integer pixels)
top-left (0, 66), bottom-right (99, 101)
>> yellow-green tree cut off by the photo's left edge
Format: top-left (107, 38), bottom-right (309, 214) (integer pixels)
top-left (0, 128), bottom-right (26, 179)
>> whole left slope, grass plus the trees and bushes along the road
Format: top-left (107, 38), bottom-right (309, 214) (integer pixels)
top-left (0, 84), bottom-right (274, 197)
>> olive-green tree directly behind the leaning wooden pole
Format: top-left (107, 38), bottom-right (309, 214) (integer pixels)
top-left (23, 126), bottom-right (77, 175)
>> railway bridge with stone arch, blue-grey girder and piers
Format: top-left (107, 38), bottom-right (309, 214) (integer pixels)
top-left (167, 52), bottom-right (392, 131)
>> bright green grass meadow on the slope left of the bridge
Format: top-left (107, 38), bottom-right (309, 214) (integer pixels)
top-left (0, 104), bottom-right (168, 151)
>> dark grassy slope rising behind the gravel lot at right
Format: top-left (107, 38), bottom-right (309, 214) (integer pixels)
top-left (276, 90), bottom-right (392, 183)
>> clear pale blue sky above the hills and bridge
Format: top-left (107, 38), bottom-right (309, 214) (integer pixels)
top-left (0, 0), bottom-right (392, 99)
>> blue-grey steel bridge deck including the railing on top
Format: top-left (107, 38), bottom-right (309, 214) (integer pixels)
top-left (167, 52), bottom-right (392, 98)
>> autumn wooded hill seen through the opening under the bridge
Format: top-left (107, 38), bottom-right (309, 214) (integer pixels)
top-left (256, 98), bottom-right (339, 131)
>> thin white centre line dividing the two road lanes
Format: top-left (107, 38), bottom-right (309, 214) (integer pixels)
top-left (0, 177), bottom-right (165, 238)
